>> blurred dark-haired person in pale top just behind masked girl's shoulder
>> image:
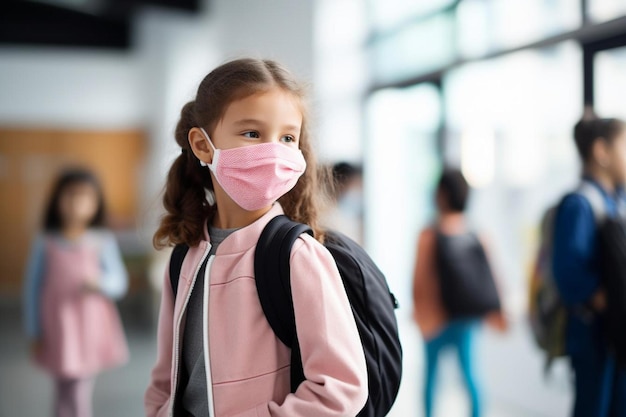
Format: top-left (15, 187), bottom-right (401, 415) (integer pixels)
top-left (323, 162), bottom-right (363, 244)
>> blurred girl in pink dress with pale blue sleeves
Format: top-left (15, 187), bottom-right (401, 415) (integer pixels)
top-left (25, 169), bottom-right (128, 417)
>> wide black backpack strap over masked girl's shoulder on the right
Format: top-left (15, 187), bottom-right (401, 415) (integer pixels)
top-left (254, 215), bottom-right (313, 392)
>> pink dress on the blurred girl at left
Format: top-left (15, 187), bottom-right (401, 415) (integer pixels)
top-left (37, 234), bottom-right (128, 378)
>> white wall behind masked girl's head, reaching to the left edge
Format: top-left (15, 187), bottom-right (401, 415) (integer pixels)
top-left (0, 0), bottom-right (314, 237)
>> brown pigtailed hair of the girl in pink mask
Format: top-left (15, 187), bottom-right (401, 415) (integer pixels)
top-left (153, 58), bottom-right (323, 249)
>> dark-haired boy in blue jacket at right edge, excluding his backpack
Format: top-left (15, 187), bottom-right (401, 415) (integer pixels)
top-left (552, 115), bottom-right (626, 417)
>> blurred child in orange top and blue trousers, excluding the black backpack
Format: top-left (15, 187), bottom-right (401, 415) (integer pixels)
top-left (413, 169), bottom-right (507, 417)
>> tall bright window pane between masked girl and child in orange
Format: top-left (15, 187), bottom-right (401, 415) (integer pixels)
top-left (365, 84), bottom-right (441, 306)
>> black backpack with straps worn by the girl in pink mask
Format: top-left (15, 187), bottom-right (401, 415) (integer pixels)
top-left (170, 216), bottom-right (402, 417)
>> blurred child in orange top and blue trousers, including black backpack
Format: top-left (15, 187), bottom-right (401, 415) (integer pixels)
top-left (413, 169), bottom-right (507, 417)
